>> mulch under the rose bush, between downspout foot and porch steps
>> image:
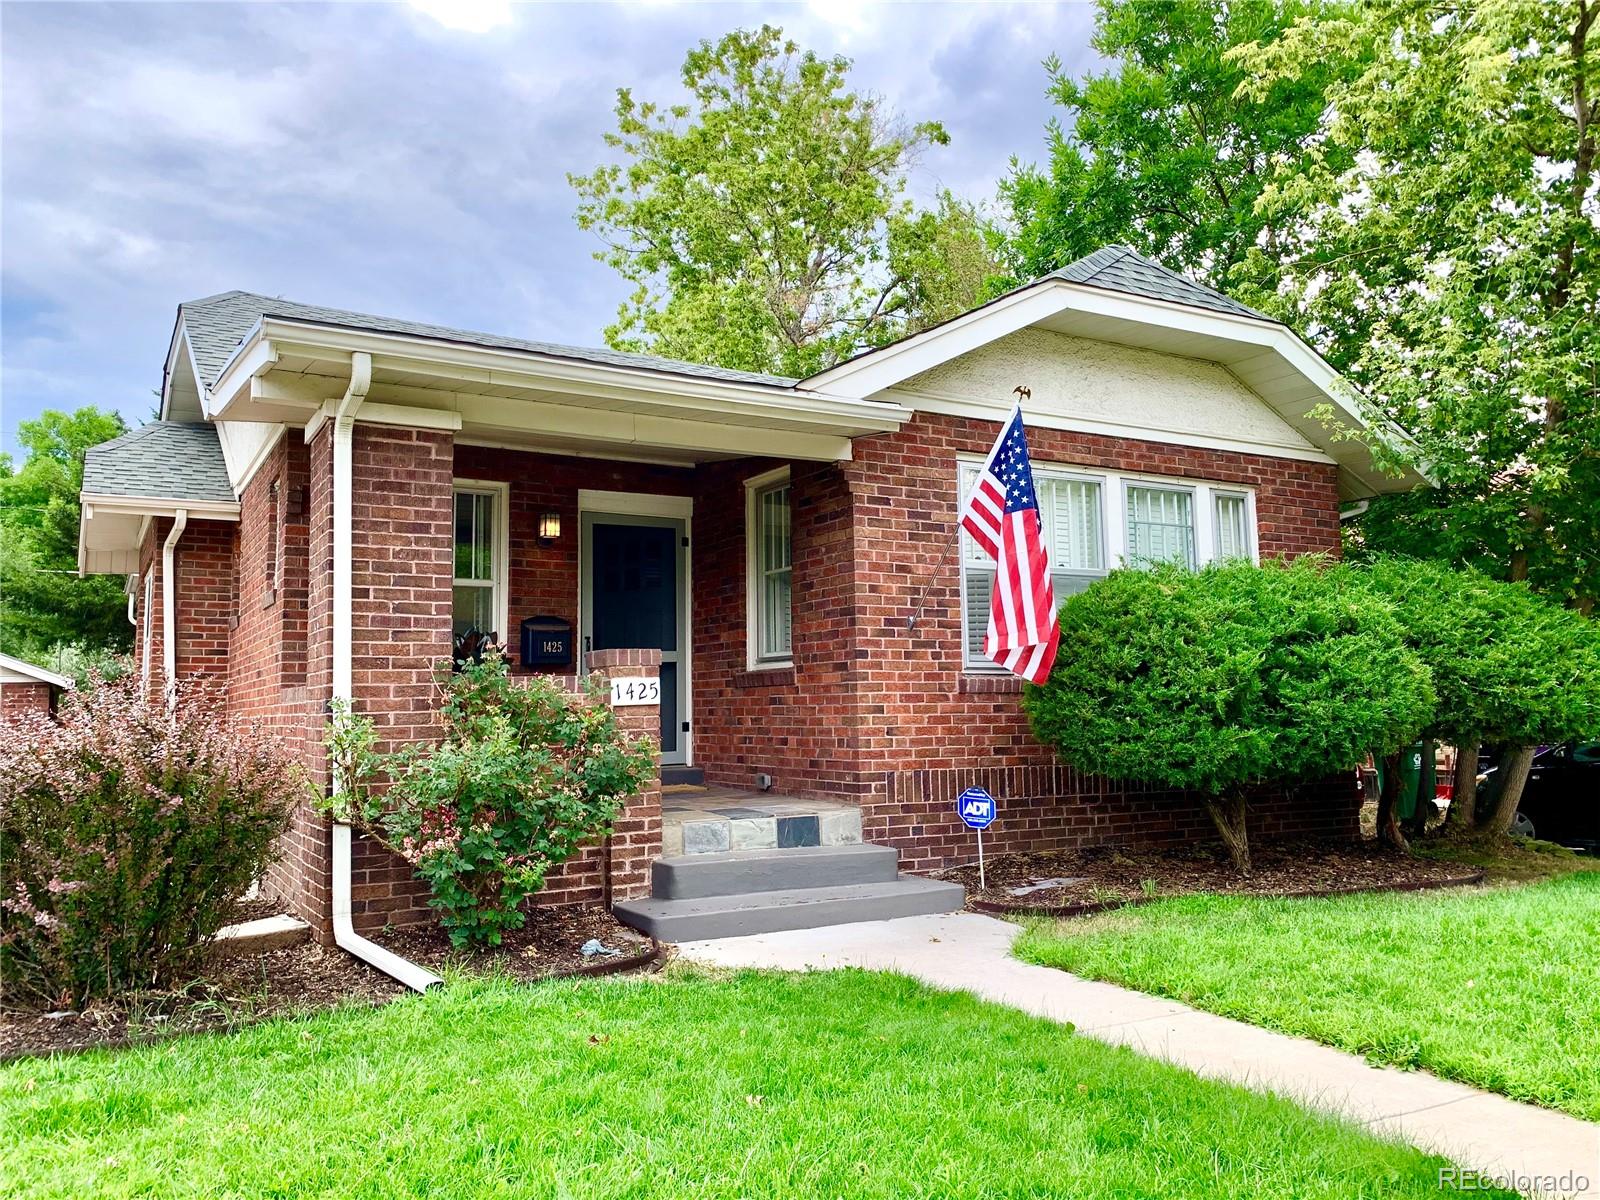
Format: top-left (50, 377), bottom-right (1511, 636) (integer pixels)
top-left (373, 907), bottom-right (659, 982)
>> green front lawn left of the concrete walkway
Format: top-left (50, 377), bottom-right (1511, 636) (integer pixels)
top-left (0, 970), bottom-right (1497, 1200)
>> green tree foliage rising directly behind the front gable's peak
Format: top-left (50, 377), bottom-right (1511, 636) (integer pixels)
top-left (1000, 0), bottom-right (1341, 315)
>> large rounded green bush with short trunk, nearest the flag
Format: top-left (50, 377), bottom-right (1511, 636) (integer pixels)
top-left (1022, 558), bottom-right (1434, 872)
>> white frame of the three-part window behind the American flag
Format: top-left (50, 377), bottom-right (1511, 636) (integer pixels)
top-left (955, 454), bottom-right (1261, 674)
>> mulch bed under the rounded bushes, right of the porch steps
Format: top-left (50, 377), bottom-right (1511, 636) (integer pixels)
top-left (939, 842), bottom-right (1482, 915)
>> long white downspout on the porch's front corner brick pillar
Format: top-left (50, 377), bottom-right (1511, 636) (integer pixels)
top-left (331, 350), bottom-right (443, 992)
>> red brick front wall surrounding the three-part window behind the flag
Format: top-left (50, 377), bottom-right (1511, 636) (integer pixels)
top-left (845, 413), bottom-right (1357, 869)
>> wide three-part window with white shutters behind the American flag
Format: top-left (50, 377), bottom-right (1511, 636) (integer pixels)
top-left (960, 462), bottom-right (1256, 670)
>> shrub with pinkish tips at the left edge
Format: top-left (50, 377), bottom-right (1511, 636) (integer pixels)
top-left (0, 678), bottom-right (306, 1005)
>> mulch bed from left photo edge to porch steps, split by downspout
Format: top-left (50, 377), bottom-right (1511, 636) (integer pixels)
top-left (0, 901), bottom-right (661, 1061)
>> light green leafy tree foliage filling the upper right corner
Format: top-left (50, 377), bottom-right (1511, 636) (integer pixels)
top-left (1229, 0), bottom-right (1600, 611)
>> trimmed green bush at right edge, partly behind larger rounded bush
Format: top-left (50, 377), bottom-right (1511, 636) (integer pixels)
top-left (1362, 557), bottom-right (1600, 834)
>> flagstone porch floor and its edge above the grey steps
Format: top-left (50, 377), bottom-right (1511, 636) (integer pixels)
top-left (661, 784), bottom-right (861, 858)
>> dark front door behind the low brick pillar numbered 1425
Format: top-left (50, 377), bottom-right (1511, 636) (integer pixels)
top-left (579, 512), bottom-right (690, 763)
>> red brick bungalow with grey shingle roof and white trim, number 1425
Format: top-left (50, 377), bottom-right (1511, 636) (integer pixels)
top-left (80, 246), bottom-right (1418, 928)
